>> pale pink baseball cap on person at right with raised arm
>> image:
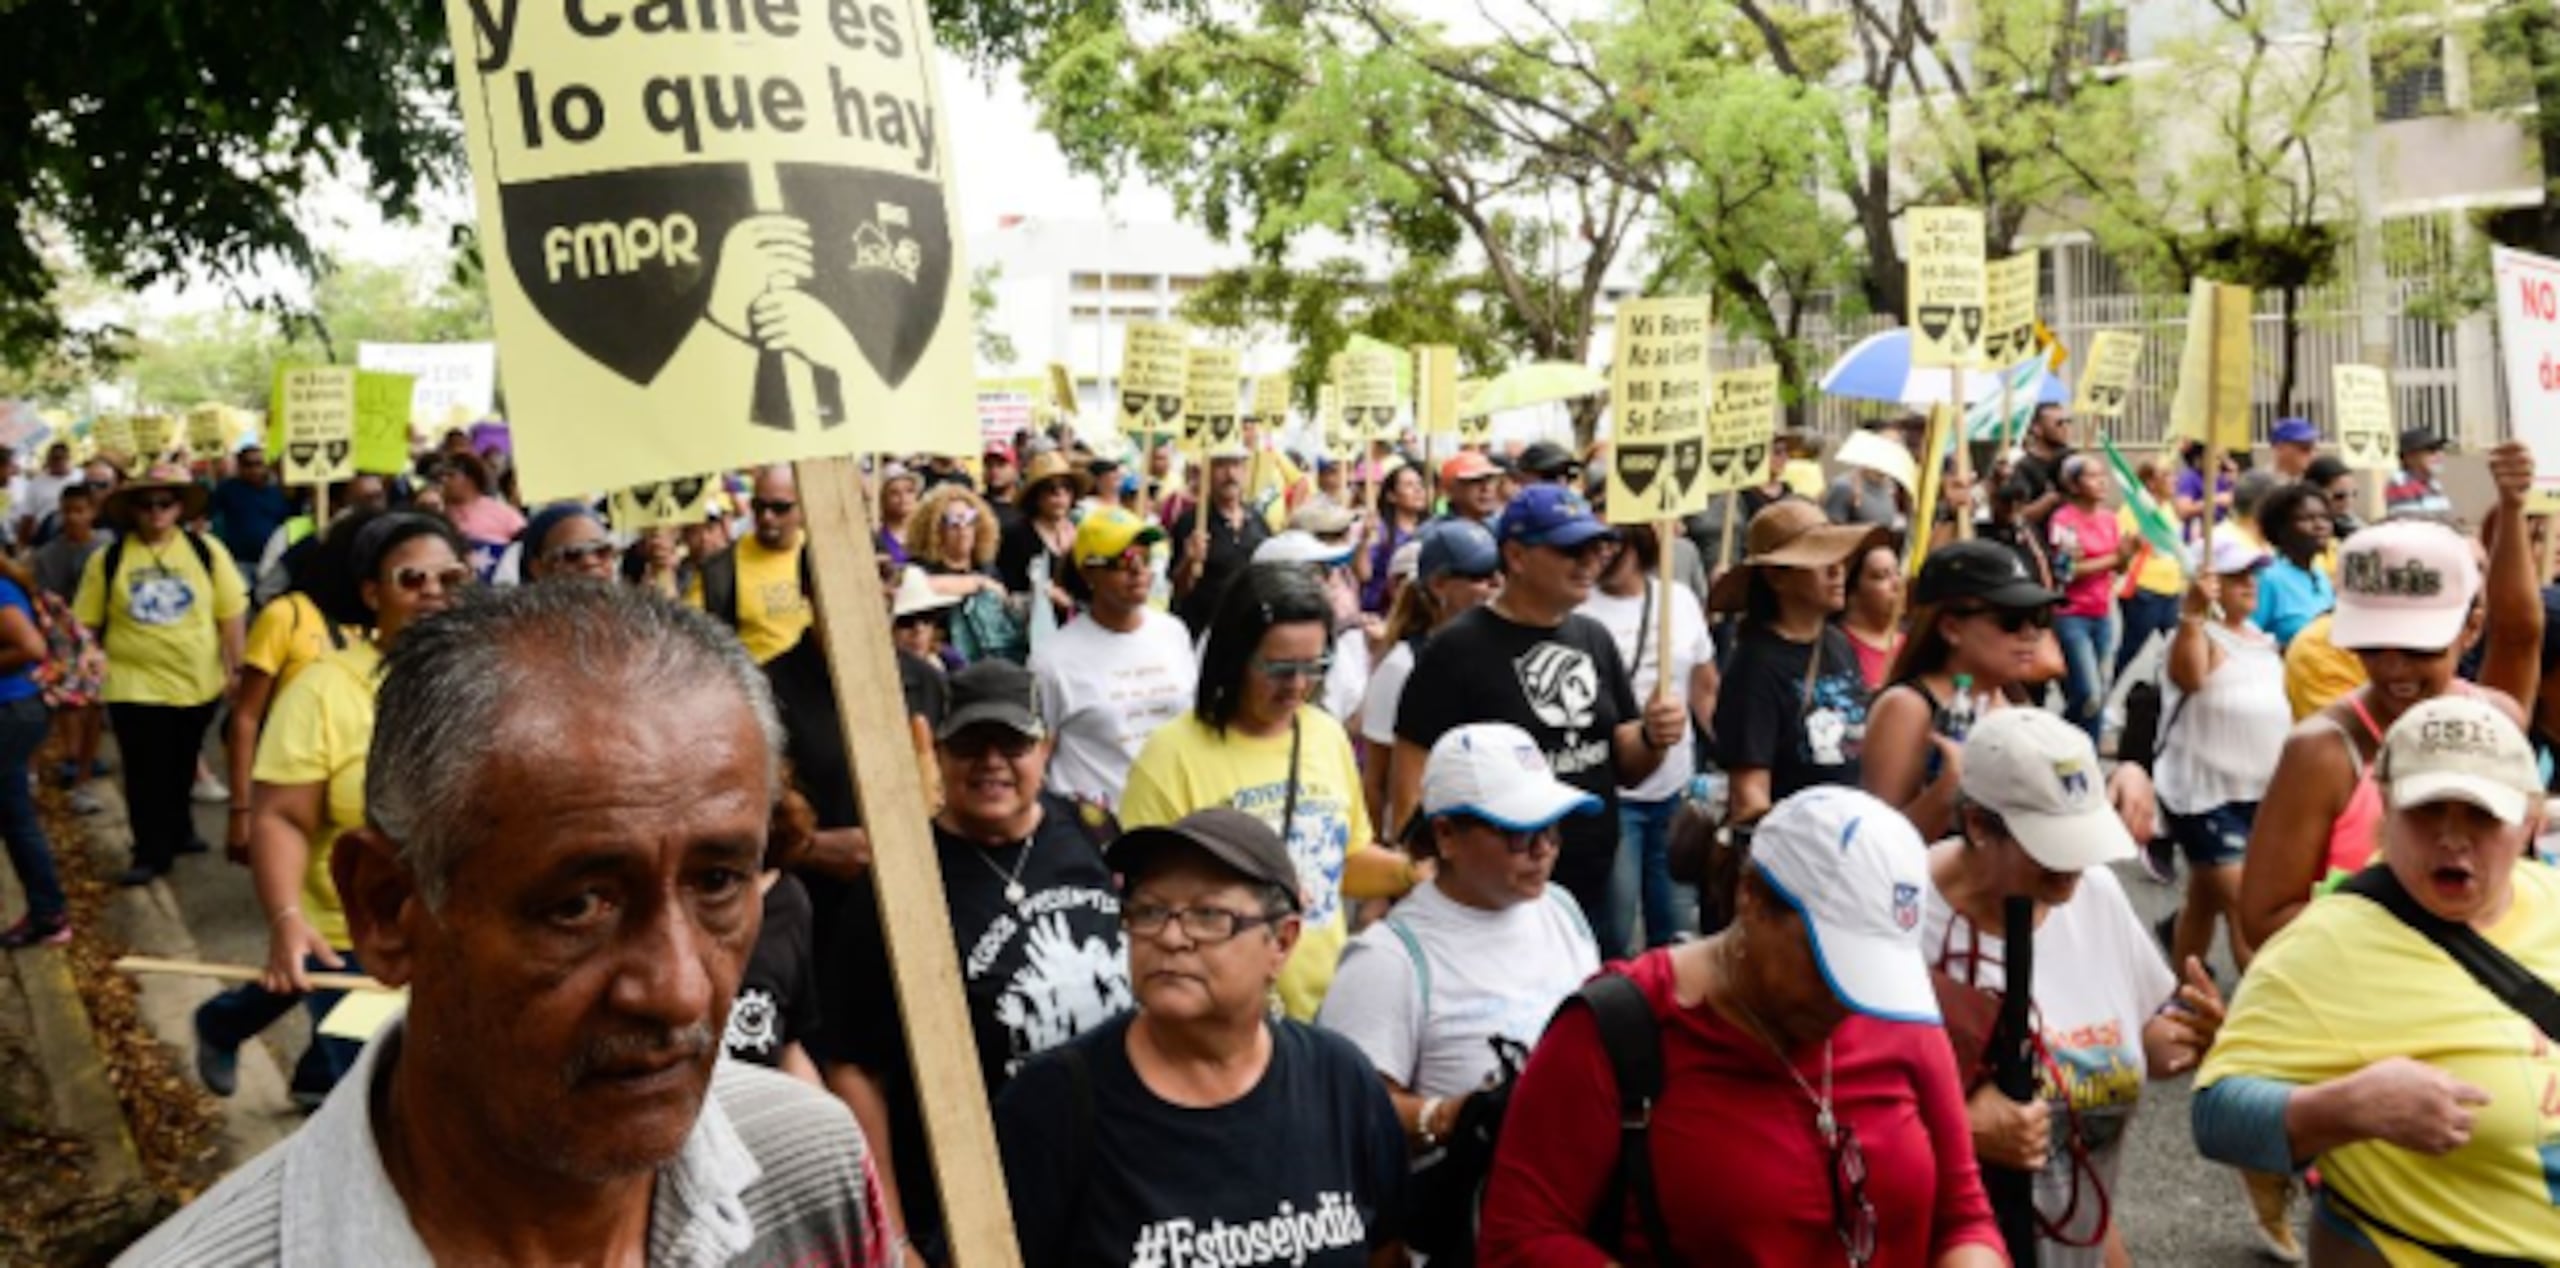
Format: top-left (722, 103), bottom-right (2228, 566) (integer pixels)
top-left (2330, 520), bottom-right (2481, 651)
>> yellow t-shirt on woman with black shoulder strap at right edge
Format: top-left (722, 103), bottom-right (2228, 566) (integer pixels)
top-left (2196, 861), bottom-right (2560, 1265)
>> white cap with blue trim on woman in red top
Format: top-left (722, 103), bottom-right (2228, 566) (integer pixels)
top-left (1751, 784), bottom-right (1938, 1025)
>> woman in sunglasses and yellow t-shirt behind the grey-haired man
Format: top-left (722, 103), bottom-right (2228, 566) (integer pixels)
top-left (195, 512), bottom-right (474, 1096)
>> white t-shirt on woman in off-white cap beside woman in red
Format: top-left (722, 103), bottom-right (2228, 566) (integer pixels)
top-left (1920, 868), bottom-right (2179, 1268)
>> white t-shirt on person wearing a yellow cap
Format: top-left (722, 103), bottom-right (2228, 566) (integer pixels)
top-left (1032, 607), bottom-right (1201, 809)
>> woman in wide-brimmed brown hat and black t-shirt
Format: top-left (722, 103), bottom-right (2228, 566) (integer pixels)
top-left (1708, 500), bottom-right (1887, 822)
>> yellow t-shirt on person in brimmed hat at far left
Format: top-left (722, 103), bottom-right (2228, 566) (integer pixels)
top-left (72, 535), bottom-right (248, 707)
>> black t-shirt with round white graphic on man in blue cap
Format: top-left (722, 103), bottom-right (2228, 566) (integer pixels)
top-left (1395, 607), bottom-right (1641, 912)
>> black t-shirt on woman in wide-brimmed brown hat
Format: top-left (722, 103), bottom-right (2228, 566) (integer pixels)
top-left (1715, 622), bottom-right (1869, 804)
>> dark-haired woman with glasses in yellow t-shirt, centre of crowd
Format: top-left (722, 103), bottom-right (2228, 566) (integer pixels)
top-left (1119, 564), bottom-right (1411, 1020)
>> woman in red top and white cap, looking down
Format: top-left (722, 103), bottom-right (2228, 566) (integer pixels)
top-left (1477, 788), bottom-right (2007, 1268)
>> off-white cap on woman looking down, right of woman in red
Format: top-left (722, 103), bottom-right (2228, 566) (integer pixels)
top-left (1964, 707), bottom-right (2135, 871)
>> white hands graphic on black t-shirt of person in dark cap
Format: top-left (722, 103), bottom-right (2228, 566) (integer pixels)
top-left (960, 889), bottom-right (1134, 1078)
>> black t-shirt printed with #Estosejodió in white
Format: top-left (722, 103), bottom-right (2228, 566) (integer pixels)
top-left (996, 1014), bottom-right (1408, 1268)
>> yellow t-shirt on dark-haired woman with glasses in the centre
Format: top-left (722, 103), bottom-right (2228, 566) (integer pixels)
top-left (1119, 707), bottom-right (1375, 1022)
